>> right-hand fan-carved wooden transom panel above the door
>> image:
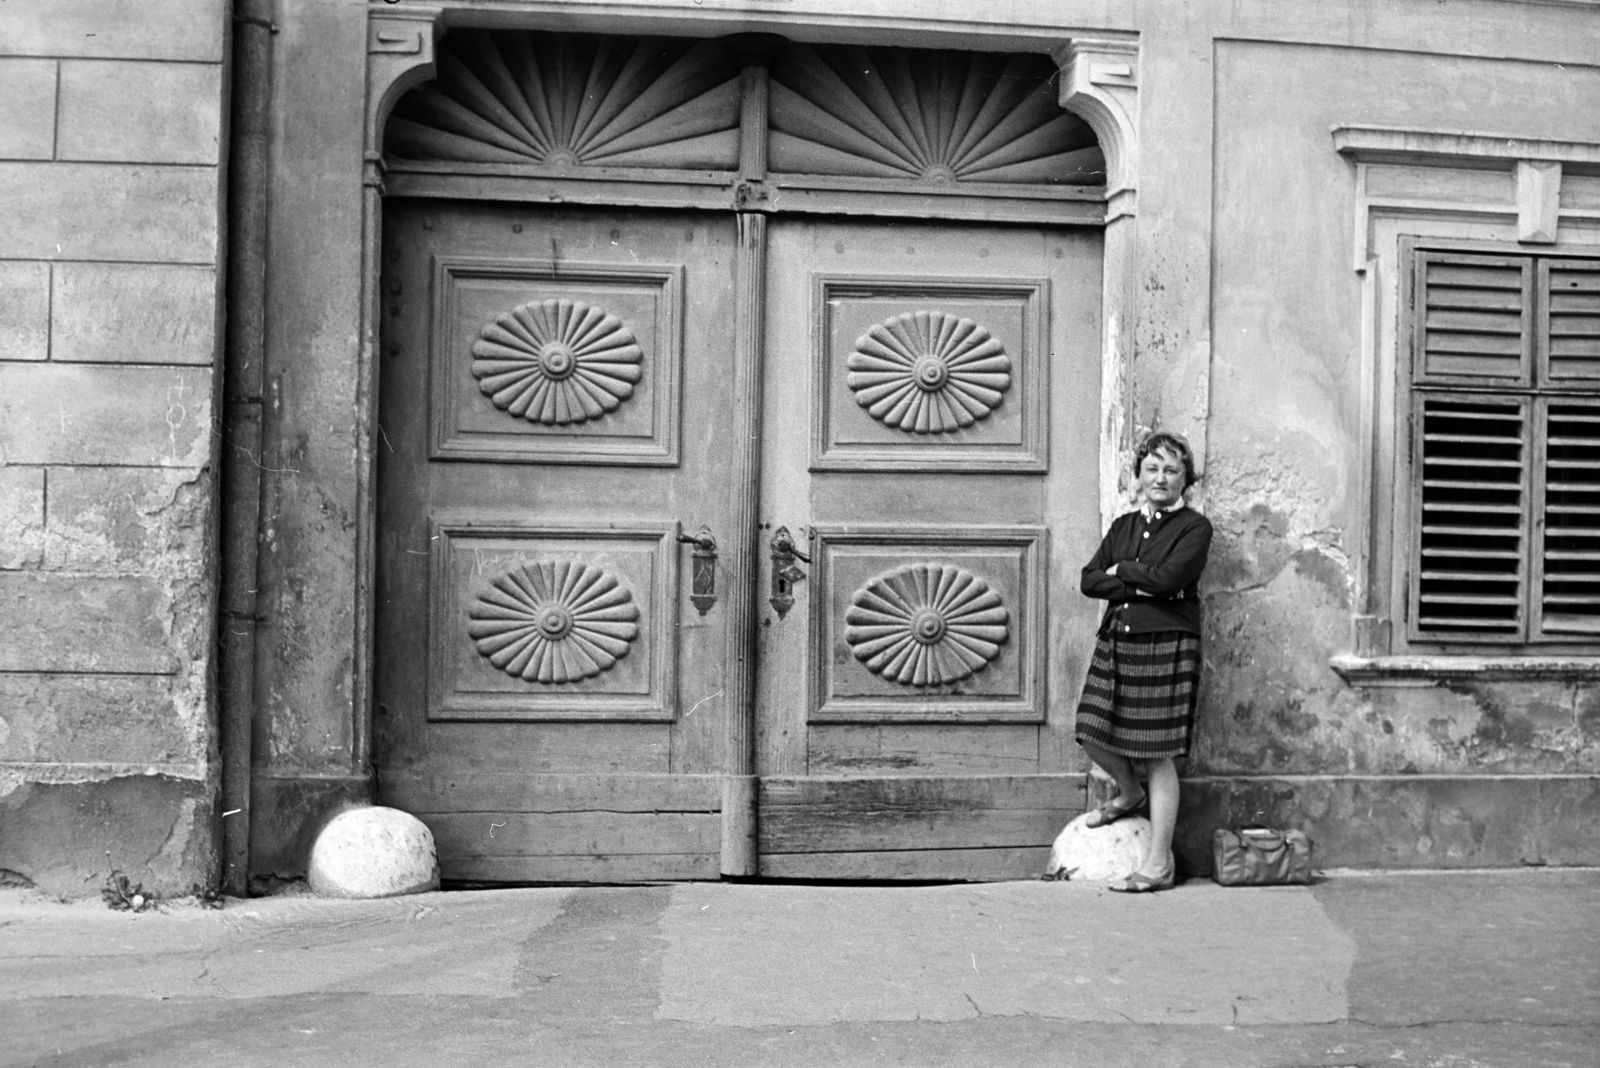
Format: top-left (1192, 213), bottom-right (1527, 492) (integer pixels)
top-left (770, 45), bottom-right (1106, 185)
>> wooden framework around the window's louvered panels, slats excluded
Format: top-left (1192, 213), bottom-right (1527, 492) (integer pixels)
top-left (1392, 235), bottom-right (1600, 656)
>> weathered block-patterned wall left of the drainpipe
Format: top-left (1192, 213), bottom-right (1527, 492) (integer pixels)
top-left (0, 0), bottom-right (229, 897)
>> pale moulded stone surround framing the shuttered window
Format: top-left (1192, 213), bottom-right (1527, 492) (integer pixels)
top-left (1330, 125), bottom-right (1600, 686)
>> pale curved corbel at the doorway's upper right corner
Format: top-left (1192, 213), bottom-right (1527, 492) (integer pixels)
top-left (1056, 37), bottom-right (1139, 222)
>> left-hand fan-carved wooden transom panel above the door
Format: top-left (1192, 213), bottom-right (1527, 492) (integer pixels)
top-left (384, 30), bottom-right (739, 169)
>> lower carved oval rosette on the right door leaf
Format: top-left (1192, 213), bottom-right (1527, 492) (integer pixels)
top-left (845, 564), bottom-right (1011, 686)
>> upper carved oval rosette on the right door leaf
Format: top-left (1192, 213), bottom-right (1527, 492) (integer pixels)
top-left (845, 312), bottom-right (1011, 433)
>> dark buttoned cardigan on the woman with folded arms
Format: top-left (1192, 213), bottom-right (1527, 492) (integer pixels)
top-left (1082, 507), bottom-right (1211, 635)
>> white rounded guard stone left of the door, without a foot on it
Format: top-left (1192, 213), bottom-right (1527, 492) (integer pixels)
top-left (307, 806), bottom-right (438, 897)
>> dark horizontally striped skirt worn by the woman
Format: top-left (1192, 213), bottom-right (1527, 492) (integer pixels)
top-left (1077, 630), bottom-right (1200, 759)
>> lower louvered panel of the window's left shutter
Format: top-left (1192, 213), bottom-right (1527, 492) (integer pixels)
top-left (1411, 393), bottom-right (1531, 641)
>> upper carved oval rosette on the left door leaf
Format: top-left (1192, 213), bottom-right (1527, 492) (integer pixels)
top-left (472, 299), bottom-right (645, 425)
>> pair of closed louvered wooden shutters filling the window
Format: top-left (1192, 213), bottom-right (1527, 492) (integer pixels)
top-left (1410, 249), bottom-right (1600, 643)
